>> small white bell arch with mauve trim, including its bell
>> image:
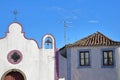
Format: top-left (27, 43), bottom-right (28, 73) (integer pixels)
top-left (42, 34), bottom-right (55, 49)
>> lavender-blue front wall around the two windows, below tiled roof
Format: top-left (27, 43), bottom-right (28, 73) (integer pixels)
top-left (68, 47), bottom-right (118, 80)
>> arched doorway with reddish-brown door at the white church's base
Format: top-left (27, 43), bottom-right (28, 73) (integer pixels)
top-left (1, 69), bottom-right (26, 80)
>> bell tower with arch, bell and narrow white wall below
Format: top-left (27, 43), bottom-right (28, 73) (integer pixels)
top-left (42, 34), bottom-right (55, 80)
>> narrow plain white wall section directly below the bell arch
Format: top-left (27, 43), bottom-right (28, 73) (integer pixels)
top-left (39, 49), bottom-right (55, 80)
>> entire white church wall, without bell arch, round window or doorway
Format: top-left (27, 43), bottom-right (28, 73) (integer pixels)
top-left (0, 23), bottom-right (55, 80)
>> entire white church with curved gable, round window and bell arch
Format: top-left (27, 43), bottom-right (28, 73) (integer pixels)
top-left (0, 22), bottom-right (56, 80)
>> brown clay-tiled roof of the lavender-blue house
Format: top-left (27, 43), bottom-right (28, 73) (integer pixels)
top-left (67, 32), bottom-right (120, 47)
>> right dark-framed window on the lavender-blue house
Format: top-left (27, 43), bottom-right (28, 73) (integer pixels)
top-left (103, 50), bottom-right (114, 66)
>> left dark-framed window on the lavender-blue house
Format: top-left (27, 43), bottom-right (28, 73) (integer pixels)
top-left (80, 51), bottom-right (90, 66)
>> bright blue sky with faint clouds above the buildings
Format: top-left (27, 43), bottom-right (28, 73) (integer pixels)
top-left (0, 0), bottom-right (120, 48)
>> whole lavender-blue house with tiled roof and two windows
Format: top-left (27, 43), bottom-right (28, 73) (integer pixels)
top-left (59, 32), bottom-right (120, 80)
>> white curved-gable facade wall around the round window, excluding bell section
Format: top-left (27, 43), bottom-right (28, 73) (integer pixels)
top-left (0, 24), bottom-right (39, 80)
